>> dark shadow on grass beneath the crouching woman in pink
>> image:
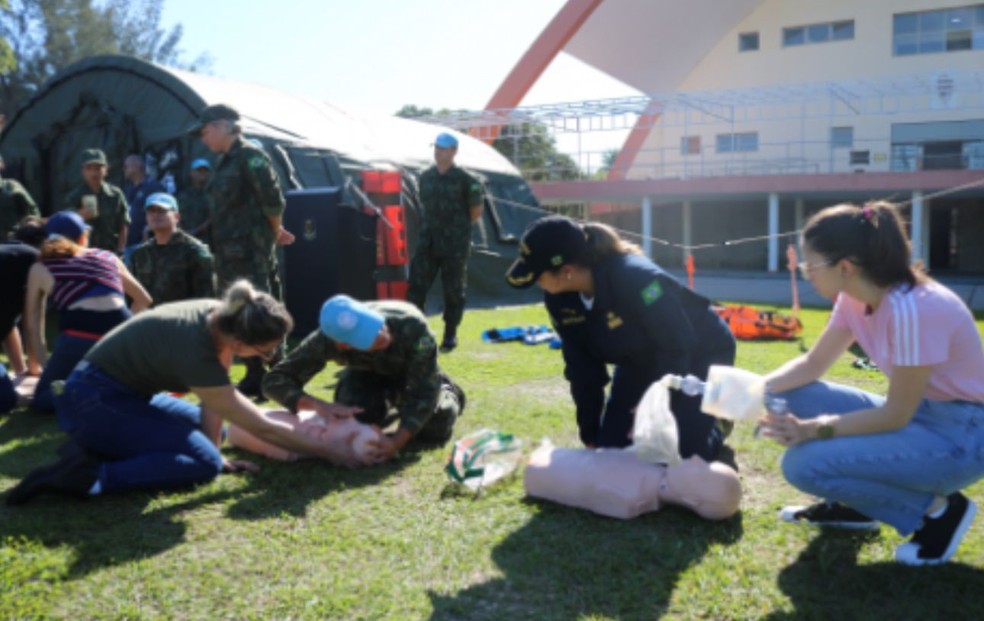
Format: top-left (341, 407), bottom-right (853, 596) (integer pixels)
top-left (764, 527), bottom-right (984, 621)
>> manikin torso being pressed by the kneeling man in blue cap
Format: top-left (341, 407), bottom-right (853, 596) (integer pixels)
top-left (228, 410), bottom-right (379, 461)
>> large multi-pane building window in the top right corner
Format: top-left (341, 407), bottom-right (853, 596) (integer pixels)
top-left (892, 4), bottom-right (984, 56)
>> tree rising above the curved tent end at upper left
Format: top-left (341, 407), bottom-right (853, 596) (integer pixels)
top-left (0, 0), bottom-right (211, 120)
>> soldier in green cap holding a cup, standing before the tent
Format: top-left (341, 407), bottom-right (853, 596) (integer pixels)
top-left (65, 149), bottom-right (130, 256)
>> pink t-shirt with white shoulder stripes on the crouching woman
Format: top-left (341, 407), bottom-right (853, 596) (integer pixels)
top-left (830, 281), bottom-right (984, 403)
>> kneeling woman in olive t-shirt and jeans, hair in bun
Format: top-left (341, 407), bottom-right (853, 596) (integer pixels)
top-left (7, 280), bottom-right (376, 505)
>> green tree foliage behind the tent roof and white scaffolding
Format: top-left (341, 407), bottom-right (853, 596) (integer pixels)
top-left (396, 104), bottom-right (580, 181)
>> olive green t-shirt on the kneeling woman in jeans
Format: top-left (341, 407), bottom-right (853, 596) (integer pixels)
top-left (85, 300), bottom-right (232, 395)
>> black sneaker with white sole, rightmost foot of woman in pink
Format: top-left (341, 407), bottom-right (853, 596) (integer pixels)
top-left (895, 492), bottom-right (977, 565)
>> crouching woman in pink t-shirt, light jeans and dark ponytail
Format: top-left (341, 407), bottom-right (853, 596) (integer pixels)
top-left (762, 202), bottom-right (984, 565)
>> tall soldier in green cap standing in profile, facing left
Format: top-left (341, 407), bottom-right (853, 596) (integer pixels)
top-left (188, 104), bottom-right (294, 397)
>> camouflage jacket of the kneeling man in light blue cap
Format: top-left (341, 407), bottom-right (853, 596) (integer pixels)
top-left (263, 300), bottom-right (441, 434)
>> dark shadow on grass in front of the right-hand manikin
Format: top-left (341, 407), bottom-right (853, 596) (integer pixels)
top-left (428, 500), bottom-right (743, 620)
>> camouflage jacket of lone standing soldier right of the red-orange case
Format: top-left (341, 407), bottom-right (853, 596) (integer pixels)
top-left (417, 166), bottom-right (482, 257)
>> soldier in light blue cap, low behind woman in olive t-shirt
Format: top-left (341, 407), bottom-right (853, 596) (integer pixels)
top-left (130, 192), bottom-right (215, 306)
